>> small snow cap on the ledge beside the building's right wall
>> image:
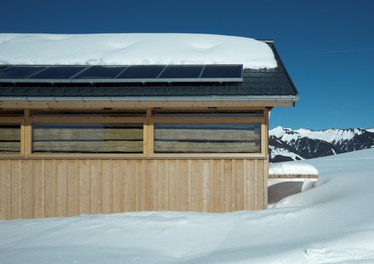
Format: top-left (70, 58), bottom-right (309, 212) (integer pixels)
top-left (269, 162), bottom-right (318, 175)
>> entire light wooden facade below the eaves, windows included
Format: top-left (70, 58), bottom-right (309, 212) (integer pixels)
top-left (0, 108), bottom-right (268, 219)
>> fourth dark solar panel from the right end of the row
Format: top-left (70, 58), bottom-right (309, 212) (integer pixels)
top-left (74, 66), bottom-right (127, 79)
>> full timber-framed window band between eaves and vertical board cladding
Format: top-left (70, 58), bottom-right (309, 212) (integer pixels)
top-left (0, 108), bottom-right (267, 159)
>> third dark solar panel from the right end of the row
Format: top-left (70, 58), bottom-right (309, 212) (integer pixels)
top-left (116, 65), bottom-right (166, 79)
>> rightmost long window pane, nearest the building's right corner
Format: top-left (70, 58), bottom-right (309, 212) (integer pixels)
top-left (154, 122), bottom-right (261, 153)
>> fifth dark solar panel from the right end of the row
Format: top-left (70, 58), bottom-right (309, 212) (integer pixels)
top-left (30, 66), bottom-right (87, 80)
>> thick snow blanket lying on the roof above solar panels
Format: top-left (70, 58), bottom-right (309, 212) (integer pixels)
top-left (0, 33), bottom-right (277, 69)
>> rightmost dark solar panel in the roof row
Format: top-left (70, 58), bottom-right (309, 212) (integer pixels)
top-left (201, 65), bottom-right (243, 78)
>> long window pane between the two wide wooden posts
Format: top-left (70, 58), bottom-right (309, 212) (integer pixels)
top-left (32, 123), bottom-right (143, 153)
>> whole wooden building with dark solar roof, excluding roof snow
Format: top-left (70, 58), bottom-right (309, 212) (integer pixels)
top-left (0, 35), bottom-right (298, 219)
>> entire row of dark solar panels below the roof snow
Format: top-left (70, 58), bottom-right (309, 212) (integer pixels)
top-left (0, 64), bottom-right (243, 83)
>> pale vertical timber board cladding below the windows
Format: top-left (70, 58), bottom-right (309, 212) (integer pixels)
top-left (0, 159), bottom-right (268, 219)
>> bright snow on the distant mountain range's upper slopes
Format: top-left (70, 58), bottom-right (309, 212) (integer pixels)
top-left (269, 126), bottom-right (369, 143)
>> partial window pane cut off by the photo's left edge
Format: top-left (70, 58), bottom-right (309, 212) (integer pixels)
top-left (0, 123), bottom-right (21, 154)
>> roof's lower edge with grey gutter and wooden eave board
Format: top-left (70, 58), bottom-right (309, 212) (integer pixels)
top-left (0, 95), bottom-right (299, 109)
